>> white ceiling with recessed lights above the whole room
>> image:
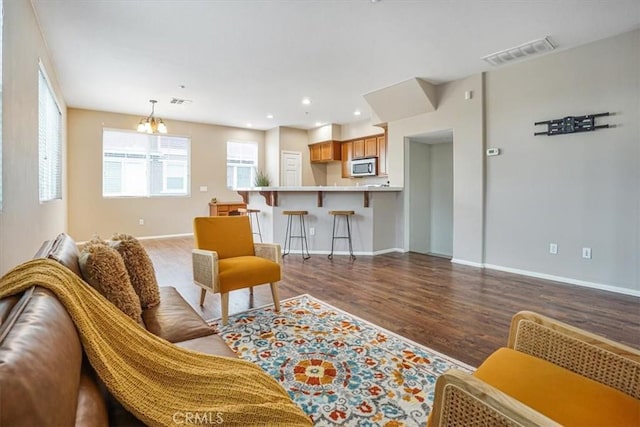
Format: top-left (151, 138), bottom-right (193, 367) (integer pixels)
top-left (32, 0), bottom-right (640, 131)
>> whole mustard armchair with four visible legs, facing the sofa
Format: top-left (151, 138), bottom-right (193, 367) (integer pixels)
top-left (192, 216), bottom-right (281, 325)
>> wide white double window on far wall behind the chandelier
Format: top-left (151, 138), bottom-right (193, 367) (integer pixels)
top-left (102, 128), bottom-right (191, 199)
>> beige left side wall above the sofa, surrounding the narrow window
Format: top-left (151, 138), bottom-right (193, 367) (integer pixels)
top-left (0, 0), bottom-right (68, 274)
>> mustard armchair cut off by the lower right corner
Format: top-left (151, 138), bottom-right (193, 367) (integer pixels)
top-left (428, 311), bottom-right (640, 427)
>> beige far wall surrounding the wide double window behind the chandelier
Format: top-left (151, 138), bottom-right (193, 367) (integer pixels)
top-left (68, 109), bottom-right (264, 240)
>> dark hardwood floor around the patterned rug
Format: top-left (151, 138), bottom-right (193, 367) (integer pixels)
top-left (143, 237), bottom-right (640, 366)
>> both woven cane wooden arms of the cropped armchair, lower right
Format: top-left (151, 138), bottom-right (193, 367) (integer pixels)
top-left (430, 311), bottom-right (640, 427)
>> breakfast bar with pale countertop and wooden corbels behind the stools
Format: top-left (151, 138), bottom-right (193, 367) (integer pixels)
top-left (236, 186), bottom-right (403, 255)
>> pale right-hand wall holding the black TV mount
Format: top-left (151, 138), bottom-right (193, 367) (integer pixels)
top-left (485, 30), bottom-right (640, 291)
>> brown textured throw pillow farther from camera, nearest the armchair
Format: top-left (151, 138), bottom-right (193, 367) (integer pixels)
top-left (111, 234), bottom-right (160, 309)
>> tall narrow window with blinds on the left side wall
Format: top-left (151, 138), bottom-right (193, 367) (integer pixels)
top-left (38, 67), bottom-right (62, 202)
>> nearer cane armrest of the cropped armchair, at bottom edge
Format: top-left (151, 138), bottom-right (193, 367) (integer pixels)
top-left (428, 369), bottom-right (560, 427)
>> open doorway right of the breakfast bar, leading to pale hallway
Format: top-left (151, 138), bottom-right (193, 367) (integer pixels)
top-left (405, 129), bottom-right (453, 258)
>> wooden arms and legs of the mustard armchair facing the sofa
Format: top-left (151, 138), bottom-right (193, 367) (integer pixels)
top-left (191, 243), bottom-right (282, 325)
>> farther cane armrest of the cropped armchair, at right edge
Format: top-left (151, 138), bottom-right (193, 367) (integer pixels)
top-left (509, 311), bottom-right (640, 399)
